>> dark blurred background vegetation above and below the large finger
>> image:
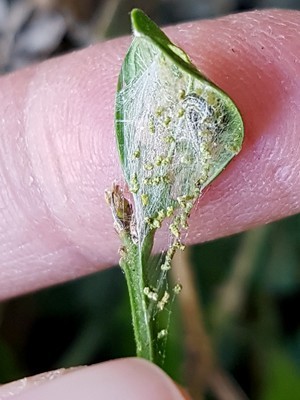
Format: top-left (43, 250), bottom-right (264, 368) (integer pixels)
top-left (0, 0), bottom-right (300, 400)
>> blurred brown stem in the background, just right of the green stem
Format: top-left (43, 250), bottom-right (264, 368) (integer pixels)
top-left (171, 249), bottom-right (247, 400)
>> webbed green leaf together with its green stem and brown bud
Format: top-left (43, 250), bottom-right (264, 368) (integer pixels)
top-left (112, 9), bottom-right (243, 363)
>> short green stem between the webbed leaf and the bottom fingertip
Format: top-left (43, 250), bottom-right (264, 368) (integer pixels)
top-left (120, 232), bottom-right (156, 362)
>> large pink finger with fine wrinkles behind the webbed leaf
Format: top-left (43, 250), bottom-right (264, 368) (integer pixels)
top-left (0, 11), bottom-right (300, 299)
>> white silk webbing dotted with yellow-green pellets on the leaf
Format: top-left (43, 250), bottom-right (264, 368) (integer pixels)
top-left (117, 41), bottom-right (238, 356)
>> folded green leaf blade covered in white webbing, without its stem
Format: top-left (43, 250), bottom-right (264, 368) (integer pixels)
top-left (116, 9), bottom-right (243, 244)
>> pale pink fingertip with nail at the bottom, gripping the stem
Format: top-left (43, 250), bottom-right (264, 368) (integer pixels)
top-left (0, 359), bottom-right (188, 400)
